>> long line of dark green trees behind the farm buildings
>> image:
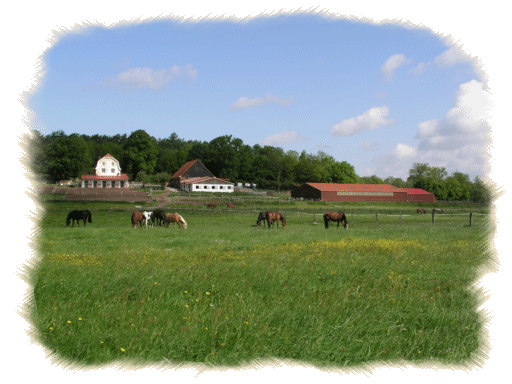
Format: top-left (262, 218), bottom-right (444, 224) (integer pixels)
top-left (30, 130), bottom-right (491, 202)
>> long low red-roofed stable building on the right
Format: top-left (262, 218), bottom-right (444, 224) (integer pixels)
top-left (291, 183), bottom-right (435, 203)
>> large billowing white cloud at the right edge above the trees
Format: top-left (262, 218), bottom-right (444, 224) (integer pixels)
top-left (372, 80), bottom-right (490, 179)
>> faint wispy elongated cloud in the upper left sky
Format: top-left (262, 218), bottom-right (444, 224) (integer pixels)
top-left (89, 64), bottom-right (197, 91)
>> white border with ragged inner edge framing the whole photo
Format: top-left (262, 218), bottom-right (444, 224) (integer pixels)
top-left (9, 0), bottom-right (512, 383)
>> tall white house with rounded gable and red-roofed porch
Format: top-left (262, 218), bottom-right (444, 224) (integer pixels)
top-left (80, 153), bottom-right (128, 188)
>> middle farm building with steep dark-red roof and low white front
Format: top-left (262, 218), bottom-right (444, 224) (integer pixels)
top-left (168, 160), bottom-right (235, 193)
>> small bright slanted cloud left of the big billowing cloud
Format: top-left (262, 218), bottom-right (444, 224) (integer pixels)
top-left (330, 106), bottom-right (393, 136)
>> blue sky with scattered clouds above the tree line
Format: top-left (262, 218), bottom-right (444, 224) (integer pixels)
top-left (29, 15), bottom-right (490, 179)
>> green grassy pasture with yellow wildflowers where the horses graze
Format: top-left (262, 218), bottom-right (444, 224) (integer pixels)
top-left (30, 196), bottom-right (491, 367)
